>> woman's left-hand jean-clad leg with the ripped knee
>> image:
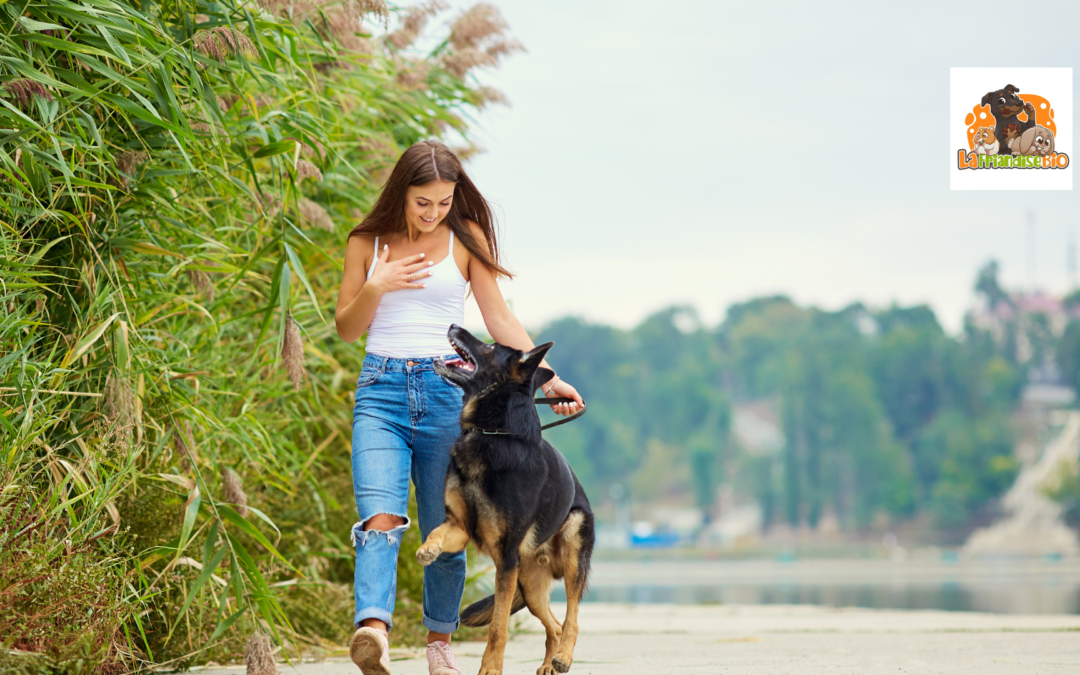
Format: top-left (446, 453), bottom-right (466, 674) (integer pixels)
top-left (352, 373), bottom-right (411, 630)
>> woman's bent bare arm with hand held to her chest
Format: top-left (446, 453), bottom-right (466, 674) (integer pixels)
top-left (334, 237), bottom-right (431, 342)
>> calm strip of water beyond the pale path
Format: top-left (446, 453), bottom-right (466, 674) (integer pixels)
top-left (552, 559), bottom-right (1080, 615)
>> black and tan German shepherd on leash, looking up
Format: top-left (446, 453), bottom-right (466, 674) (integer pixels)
top-left (416, 325), bottom-right (596, 675)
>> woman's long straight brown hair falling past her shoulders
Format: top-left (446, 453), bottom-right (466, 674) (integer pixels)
top-left (349, 140), bottom-right (513, 279)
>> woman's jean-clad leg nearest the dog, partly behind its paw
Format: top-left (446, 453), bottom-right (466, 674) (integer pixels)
top-left (413, 372), bottom-right (465, 643)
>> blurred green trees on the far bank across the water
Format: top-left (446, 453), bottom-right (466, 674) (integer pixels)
top-left (542, 265), bottom-right (1036, 529)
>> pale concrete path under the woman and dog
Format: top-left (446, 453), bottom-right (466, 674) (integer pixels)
top-left (196, 603), bottom-right (1080, 675)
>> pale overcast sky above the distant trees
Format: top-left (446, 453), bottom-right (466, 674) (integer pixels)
top-left (431, 0), bottom-right (1080, 332)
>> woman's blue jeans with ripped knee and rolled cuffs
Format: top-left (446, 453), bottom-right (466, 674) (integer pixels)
top-left (352, 354), bottom-right (465, 633)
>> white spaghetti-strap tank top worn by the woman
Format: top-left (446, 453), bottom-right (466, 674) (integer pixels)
top-left (367, 230), bottom-right (469, 359)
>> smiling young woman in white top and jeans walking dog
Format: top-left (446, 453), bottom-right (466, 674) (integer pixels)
top-left (335, 140), bottom-right (584, 675)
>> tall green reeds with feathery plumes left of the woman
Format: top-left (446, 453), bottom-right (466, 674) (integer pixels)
top-left (0, 0), bottom-right (519, 672)
